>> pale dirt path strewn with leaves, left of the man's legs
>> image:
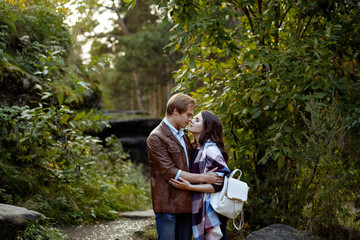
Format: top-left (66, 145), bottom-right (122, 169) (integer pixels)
top-left (60, 211), bottom-right (155, 240)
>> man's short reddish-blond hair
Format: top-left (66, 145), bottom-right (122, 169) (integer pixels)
top-left (166, 93), bottom-right (196, 116)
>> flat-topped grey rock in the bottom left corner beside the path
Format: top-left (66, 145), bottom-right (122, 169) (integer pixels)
top-left (0, 204), bottom-right (45, 240)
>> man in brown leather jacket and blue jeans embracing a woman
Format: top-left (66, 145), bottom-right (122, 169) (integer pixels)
top-left (147, 93), bottom-right (223, 240)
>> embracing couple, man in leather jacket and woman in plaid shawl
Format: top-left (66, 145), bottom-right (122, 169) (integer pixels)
top-left (147, 93), bottom-right (230, 240)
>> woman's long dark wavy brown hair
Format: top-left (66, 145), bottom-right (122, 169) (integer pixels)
top-left (198, 111), bottom-right (229, 162)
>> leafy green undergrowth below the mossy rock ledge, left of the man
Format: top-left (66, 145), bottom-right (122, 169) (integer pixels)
top-left (0, 105), bottom-right (150, 223)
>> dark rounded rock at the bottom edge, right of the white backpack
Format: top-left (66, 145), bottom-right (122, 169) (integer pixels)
top-left (246, 224), bottom-right (311, 240)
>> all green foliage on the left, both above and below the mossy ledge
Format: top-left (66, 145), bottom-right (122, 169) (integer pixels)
top-left (0, 0), bottom-right (150, 227)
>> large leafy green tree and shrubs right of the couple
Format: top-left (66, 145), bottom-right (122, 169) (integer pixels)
top-left (160, 0), bottom-right (360, 238)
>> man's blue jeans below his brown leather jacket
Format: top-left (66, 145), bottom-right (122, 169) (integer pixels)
top-left (155, 213), bottom-right (192, 240)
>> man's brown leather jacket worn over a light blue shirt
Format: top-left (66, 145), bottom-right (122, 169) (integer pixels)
top-left (146, 121), bottom-right (192, 214)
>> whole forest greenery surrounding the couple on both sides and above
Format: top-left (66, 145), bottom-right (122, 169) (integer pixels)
top-left (0, 0), bottom-right (360, 239)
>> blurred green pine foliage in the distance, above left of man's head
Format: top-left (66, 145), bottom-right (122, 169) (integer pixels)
top-left (101, 24), bottom-right (176, 109)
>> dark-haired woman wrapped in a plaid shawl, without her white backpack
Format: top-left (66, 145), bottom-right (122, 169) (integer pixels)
top-left (170, 111), bottom-right (230, 240)
